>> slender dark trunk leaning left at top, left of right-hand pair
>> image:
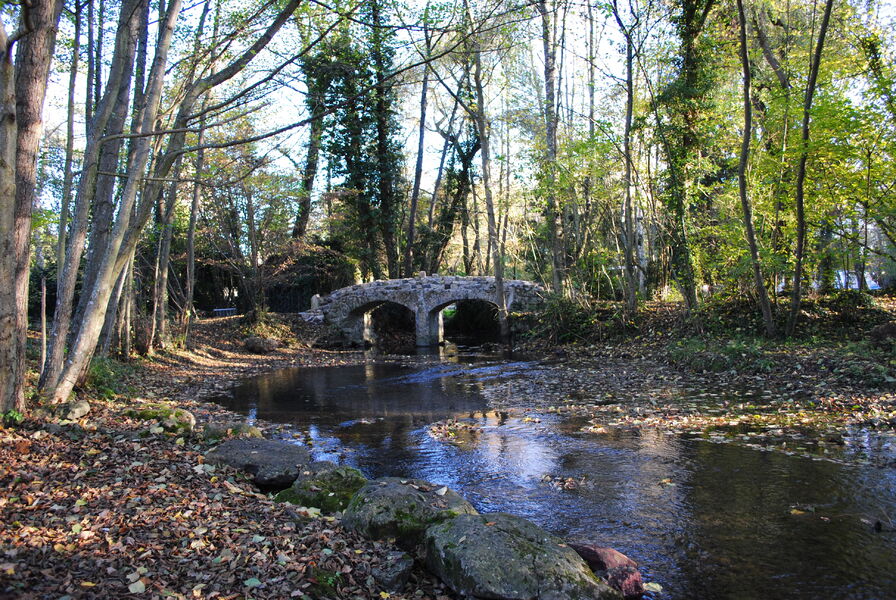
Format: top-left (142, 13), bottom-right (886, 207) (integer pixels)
top-left (737, 0), bottom-right (777, 337)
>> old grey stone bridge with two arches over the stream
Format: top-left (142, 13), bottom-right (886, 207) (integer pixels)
top-left (312, 273), bottom-right (544, 346)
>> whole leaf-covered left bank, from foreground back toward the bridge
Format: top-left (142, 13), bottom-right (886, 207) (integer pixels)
top-left (0, 318), bottom-right (453, 600)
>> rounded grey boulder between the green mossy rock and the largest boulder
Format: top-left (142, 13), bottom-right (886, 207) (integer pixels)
top-left (342, 477), bottom-right (476, 549)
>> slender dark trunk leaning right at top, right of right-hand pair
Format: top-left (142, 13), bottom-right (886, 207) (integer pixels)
top-left (787, 0), bottom-right (834, 336)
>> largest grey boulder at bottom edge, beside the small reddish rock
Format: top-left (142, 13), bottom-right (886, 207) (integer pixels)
top-left (424, 513), bottom-right (621, 600)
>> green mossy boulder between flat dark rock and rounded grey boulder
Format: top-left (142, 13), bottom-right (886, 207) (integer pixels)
top-left (274, 460), bottom-right (367, 513)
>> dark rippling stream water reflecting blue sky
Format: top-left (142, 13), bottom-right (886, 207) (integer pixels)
top-left (219, 355), bottom-right (896, 600)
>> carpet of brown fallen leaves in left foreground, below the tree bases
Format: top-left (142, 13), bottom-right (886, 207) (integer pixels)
top-left (0, 402), bottom-right (456, 600)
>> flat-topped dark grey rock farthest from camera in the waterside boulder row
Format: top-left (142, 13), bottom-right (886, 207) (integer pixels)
top-left (205, 439), bottom-right (311, 490)
